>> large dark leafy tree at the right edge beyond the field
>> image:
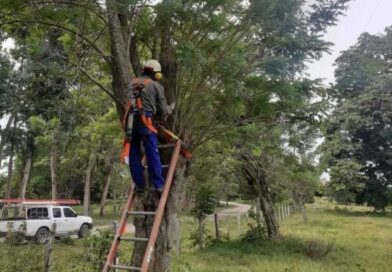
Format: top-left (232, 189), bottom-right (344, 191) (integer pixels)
top-left (324, 28), bottom-right (392, 210)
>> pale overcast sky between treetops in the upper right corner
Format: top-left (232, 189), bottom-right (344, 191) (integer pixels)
top-left (307, 0), bottom-right (392, 83)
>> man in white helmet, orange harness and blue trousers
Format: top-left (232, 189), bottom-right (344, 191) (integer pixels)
top-left (123, 60), bottom-right (172, 194)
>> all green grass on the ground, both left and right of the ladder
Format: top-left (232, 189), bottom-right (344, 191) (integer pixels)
top-left (0, 198), bottom-right (392, 272)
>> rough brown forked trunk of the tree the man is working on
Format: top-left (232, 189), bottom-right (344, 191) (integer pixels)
top-left (106, 0), bottom-right (186, 272)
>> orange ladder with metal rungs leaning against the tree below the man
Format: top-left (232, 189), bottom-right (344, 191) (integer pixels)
top-left (102, 138), bottom-right (182, 272)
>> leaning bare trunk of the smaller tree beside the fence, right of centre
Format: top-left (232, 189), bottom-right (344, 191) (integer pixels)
top-left (241, 152), bottom-right (280, 239)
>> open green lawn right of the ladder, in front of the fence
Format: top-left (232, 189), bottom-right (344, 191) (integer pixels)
top-left (173, 202), bottom-right (392, 272)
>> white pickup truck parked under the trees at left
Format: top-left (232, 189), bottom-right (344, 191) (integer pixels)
top-left (0, 204), bottom-right (93, 243)
